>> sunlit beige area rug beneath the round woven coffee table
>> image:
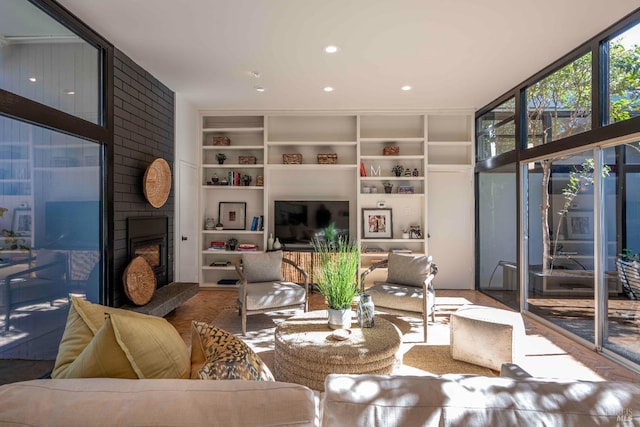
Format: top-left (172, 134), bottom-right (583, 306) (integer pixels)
top-left (212, 309), bottom-right (498, 376)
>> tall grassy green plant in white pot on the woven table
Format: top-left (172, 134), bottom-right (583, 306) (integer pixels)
top-left (313, 237), bottom-right (360, 329)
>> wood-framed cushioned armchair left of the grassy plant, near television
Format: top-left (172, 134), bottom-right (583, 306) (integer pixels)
top-left (235, 251), bottom-right (309, 335)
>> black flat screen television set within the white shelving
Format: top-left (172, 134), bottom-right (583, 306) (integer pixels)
top-left (274, 200), bottom-right (349, 249)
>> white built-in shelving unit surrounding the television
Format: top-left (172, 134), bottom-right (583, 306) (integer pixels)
top-left (199, 111), bottom-right (474, 289)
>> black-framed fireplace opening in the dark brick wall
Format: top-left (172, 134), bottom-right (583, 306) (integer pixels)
top-left (127, 216), bottom-right (169, 288)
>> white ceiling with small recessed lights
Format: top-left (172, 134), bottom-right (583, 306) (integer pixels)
top-left (59, 0), bottom-right (640, 110)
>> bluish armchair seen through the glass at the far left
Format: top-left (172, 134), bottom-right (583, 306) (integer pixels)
top-left (0, 249), bottom-right (69, 332)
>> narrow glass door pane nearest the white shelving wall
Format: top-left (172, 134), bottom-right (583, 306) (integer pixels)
top-left (477, 163), bottom-right (519, 309)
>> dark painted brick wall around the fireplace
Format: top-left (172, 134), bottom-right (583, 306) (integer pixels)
top-left (107, 49), bottom-right (175, 307)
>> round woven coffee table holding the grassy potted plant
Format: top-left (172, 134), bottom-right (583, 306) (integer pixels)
top-left (274, 310), bottom-right (401, 391)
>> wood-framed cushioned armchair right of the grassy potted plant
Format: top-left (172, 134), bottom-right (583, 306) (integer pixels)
top-left (360, 253), bottom-right (438, 342)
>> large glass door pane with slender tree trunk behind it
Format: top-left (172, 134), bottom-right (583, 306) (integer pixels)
top-left (527, 150), bottom-right (604, 342)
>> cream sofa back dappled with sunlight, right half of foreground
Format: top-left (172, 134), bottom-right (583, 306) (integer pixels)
top-left (322, 374), bottom-right (640, 427)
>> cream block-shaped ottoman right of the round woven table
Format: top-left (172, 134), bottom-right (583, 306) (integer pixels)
top-left (450, 305), bottom-right (525, 372)
